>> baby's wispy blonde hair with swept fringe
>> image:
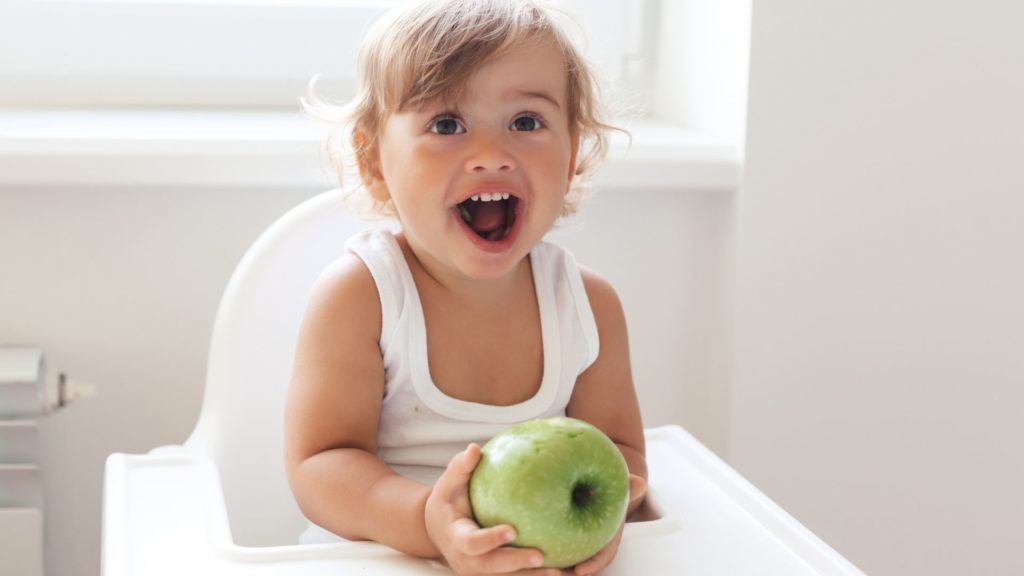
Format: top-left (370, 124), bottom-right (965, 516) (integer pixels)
top-left (302, 0), bottom-right (617, 216)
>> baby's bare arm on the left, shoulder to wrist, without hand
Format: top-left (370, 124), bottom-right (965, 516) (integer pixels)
top-left (285, 255), bottom-right (438, 557)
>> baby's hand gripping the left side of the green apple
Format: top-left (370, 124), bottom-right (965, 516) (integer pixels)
top-left (424, 444), bottom-right (561, 576)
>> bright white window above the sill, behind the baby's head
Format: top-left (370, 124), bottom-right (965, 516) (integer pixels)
top-left (0, 0), bottom-right (648, 109)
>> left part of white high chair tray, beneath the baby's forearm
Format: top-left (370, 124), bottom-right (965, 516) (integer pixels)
top-left (101, 447), bottom-right (437, 576)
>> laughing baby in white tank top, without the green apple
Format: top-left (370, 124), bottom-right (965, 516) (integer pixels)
top-left (286, 0), bottom-right (647, 574)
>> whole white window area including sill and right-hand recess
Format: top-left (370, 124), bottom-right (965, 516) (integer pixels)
top-left (0, 0), bottom-right (751, 190)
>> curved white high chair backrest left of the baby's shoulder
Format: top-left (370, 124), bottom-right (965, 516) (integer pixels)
top-left (185, 191), bottom-right (367, 546)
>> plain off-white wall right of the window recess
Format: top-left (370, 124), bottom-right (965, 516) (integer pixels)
top-left (730, 0), bottom-right (1024, 576)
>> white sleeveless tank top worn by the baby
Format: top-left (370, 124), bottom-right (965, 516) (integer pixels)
top-left (346, 229), bottom-right (598, 484)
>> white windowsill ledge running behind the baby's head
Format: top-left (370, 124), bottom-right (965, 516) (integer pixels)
top-left (0, 110), bottom-right (741, 190)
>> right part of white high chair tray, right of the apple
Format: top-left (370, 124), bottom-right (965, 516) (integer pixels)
top-left (611, 425), bottom-right (864, 576)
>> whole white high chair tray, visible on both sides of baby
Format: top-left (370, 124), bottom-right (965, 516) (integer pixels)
top-left (102, 426), bottom-right (862, 576)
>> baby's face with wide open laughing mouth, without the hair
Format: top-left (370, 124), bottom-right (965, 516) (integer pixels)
top-left (367, 42), bottom-right (579, 279)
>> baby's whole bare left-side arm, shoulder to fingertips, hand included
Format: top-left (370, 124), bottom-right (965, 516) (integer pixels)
top-left (285, 256), bottom-right (557, 574)
